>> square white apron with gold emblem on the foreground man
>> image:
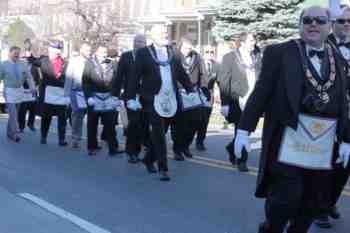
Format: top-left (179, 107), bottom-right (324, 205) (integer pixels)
top-left (278, 114), bottom-right (337, 170)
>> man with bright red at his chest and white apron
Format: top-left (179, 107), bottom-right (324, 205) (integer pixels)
top-left (39, 43), bottom-right (70, 146)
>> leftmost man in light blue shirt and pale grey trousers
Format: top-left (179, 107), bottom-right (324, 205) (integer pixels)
top-left (0, 46), bottom-right (36, 142)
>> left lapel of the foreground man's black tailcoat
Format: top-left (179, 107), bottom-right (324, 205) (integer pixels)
top-left (283, 42), bottom-right (305, 114)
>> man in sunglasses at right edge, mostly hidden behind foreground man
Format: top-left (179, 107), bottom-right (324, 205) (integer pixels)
top-left (315, 7), bottom-right (350, 228)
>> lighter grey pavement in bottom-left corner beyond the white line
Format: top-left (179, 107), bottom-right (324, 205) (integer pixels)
top-left (0, 187), bottom-right (86, 233)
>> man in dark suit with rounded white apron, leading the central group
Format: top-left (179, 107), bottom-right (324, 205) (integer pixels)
top-left (126, 26), bottom-right (192, 181)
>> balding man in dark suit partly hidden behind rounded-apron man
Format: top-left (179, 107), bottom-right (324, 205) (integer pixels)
top-left (113, 34), bottom-right (148, 163)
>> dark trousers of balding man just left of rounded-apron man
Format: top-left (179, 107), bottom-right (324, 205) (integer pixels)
top-left (125, 109), bottom-right (149, 156)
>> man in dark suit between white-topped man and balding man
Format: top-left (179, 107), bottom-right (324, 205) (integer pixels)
top-left (82, 45), bottom-right (121, 156)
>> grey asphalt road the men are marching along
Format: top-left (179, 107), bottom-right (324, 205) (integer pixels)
top-left (0, 115), bottom-right (350, 233)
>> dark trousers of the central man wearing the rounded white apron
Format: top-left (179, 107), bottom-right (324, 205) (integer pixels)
top-left (144, 107), bottom-right (177, 171)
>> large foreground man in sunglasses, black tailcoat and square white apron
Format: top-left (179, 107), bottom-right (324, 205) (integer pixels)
top-left (234, 6), bottom-right (350, 233)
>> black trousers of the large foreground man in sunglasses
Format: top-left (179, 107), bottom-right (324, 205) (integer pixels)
top-left (265, 162), bottom-right (332, 233)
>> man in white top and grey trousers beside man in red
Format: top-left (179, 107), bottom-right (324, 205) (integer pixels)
top-left (64, 43), bottom-right (91, 148)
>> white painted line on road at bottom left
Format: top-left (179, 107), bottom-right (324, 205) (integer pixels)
top-left (18, 193), bottom-right (111, 233)
